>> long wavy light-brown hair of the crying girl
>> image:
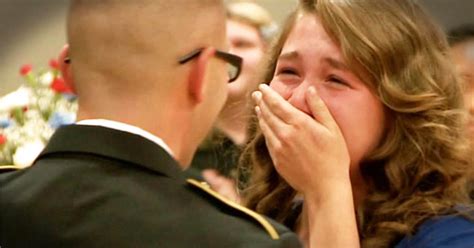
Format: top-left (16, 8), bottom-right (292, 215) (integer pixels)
top-left (240, 0), bottom-right (472, 247)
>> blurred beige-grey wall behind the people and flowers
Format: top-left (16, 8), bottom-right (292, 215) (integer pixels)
top-left (0, 0), bottom-right (474, 95)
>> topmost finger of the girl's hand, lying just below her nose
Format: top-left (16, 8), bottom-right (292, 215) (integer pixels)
top-left (259, 84), bottom-right (303, 124)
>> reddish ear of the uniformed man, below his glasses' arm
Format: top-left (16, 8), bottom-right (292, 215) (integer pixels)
top-left (188, 48), bottom-right (216, 103)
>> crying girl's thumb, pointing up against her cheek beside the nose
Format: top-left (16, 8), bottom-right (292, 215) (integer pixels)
top-left (306, 86), bottom-right (337, 128)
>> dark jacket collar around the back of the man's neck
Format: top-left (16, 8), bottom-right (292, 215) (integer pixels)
top-left (38, 125), bottom-right (184, 181)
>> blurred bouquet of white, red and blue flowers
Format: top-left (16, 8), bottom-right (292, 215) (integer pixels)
top-left (0, 60), bottom-right (77, 168)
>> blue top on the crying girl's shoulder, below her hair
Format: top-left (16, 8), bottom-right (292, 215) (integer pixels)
top-left (395, 215), bottom-right (474, 248)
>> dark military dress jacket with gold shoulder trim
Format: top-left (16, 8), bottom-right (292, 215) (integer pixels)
top-left (0, 125), bottom-right (301, 248)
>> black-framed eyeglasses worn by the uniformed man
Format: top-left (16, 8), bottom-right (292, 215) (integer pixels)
top-left (178, 48), bottom-right (242, 83)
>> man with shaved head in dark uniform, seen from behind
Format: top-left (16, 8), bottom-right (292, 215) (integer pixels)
top-left (0, 0), bottom-right (299, 248)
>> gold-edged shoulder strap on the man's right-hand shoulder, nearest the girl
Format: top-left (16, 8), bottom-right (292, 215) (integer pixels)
top-left (186, 179), bottom-right (280, 240)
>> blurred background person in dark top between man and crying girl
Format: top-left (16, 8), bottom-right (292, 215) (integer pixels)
top-left (192, 1), bottom-right (277, 200)
